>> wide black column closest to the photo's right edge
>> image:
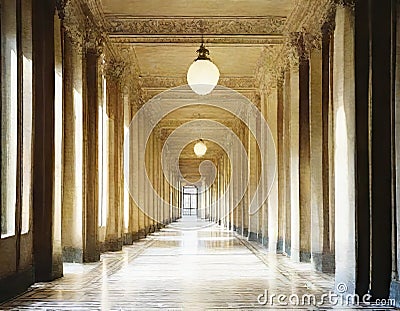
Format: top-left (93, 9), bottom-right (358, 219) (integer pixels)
top-left (368, 0), bottom-right (392, 304)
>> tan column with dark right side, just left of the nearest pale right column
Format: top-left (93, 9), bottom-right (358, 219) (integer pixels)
top-left (310, 31), bottom-right (335, 273)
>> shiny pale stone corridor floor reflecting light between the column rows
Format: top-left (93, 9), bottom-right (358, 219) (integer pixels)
top-left (0, 217), bottom-right (394, 310)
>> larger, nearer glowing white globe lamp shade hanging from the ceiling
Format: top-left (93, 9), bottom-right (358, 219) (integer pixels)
top-left (187, 59), bottom-right (219, 95)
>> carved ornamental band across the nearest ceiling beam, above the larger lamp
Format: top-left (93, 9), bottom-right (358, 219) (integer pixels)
top-left (106, 16), bottom-right (286, 35)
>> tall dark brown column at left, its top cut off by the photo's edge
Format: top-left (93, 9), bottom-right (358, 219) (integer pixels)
top-left (32, 1), bottom-right (63, 281)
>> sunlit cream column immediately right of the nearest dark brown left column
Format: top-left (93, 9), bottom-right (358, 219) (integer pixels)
top-left (61, 34), bottom-right (83, 262)
